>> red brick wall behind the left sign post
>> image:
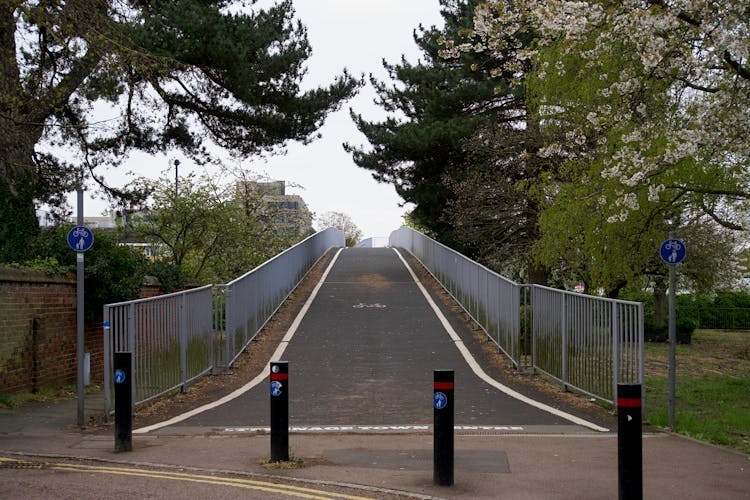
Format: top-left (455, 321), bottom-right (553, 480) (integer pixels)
top-left (0, 268), bottom-right (103, 393)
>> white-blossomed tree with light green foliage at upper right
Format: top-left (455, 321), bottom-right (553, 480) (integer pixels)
top-left (464, 0), bottom-right (750, 229)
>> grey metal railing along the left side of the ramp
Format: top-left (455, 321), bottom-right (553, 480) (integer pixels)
top-left (104, 228), bottom-right (345, 415)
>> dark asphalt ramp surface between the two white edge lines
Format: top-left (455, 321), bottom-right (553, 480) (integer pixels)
top-left (174, 248), bottom-right (571, 432)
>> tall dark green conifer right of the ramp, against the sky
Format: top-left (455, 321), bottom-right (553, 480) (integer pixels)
top-left (344, 0), bottom-right (514, 250)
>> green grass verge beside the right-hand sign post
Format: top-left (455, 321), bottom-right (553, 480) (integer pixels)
top-left (646, 330), bottom-right (750, 453)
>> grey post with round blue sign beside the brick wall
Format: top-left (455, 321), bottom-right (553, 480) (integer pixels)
top-left (68, 188), bottom-right (94, 427)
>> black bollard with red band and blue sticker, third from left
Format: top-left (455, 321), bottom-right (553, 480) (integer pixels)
top-left (433, 370), bottom-right (454, 486)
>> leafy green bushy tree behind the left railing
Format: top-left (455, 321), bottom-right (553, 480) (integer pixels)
top-left (123, 172), bottom-right (306, 283)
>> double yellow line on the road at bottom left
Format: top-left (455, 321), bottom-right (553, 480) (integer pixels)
top-left (0, 457), bottom-right (371, 500)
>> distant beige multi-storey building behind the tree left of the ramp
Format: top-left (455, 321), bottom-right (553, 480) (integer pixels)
top-left (235, 181), bottom-right (312, 234)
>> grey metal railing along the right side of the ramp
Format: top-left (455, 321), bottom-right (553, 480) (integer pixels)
top-left (390, 227), bottom-right (644, 404)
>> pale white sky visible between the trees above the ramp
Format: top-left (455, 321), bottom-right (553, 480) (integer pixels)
top-left (70, 0), bottom-right (442, 238)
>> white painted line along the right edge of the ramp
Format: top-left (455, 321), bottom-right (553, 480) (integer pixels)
top-left (393, 248), bottom-right (609, 432)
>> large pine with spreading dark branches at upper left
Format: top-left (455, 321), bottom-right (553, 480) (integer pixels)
top-left (0, 0), bottom-right (359, 259)
